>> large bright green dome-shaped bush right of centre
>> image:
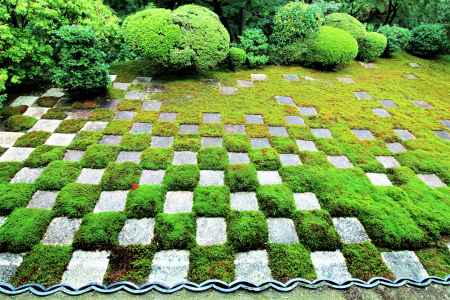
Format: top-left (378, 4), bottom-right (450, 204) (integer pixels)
top-left (304, 26), bottom-right (358, 69)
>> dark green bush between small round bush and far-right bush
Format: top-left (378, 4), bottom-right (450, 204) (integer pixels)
top-left (378, 25), bottom-right (411, 57)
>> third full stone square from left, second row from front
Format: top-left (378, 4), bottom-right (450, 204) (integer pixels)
top-left (196, 218), bottom-right (227, 246)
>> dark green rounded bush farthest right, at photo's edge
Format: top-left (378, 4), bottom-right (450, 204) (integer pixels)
top-left (408, 24), bottom-right (448, 58)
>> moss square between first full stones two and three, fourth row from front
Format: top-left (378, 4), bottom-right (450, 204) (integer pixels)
top-left (101, 162), bottom-right (142, 191)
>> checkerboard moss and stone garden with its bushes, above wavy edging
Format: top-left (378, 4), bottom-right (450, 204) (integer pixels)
top-left (0, 0), bottom-right (450, 287)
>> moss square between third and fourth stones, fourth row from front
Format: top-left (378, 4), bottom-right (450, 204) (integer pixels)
top-left (164, 165), bottom-right (200, 191)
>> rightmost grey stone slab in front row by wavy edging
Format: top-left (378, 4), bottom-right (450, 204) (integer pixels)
top-left (381, 251), bottom-right (428, 281)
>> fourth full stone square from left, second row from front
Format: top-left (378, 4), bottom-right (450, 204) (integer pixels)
top-left (267, 218), bottom-right (298, 244)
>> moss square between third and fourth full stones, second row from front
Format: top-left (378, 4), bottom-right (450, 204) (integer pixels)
top-left (227, 211), bottom-right (268, 252)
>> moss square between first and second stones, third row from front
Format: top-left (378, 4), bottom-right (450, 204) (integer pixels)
top-left (53, 183), bottom-right (100, 218)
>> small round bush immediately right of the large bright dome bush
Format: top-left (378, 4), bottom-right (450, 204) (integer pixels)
top-left (358, 32), bottom-right (387, 62)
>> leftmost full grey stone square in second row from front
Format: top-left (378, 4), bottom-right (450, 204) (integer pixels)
top-left (42, 217), bottom-right (81, 245)
